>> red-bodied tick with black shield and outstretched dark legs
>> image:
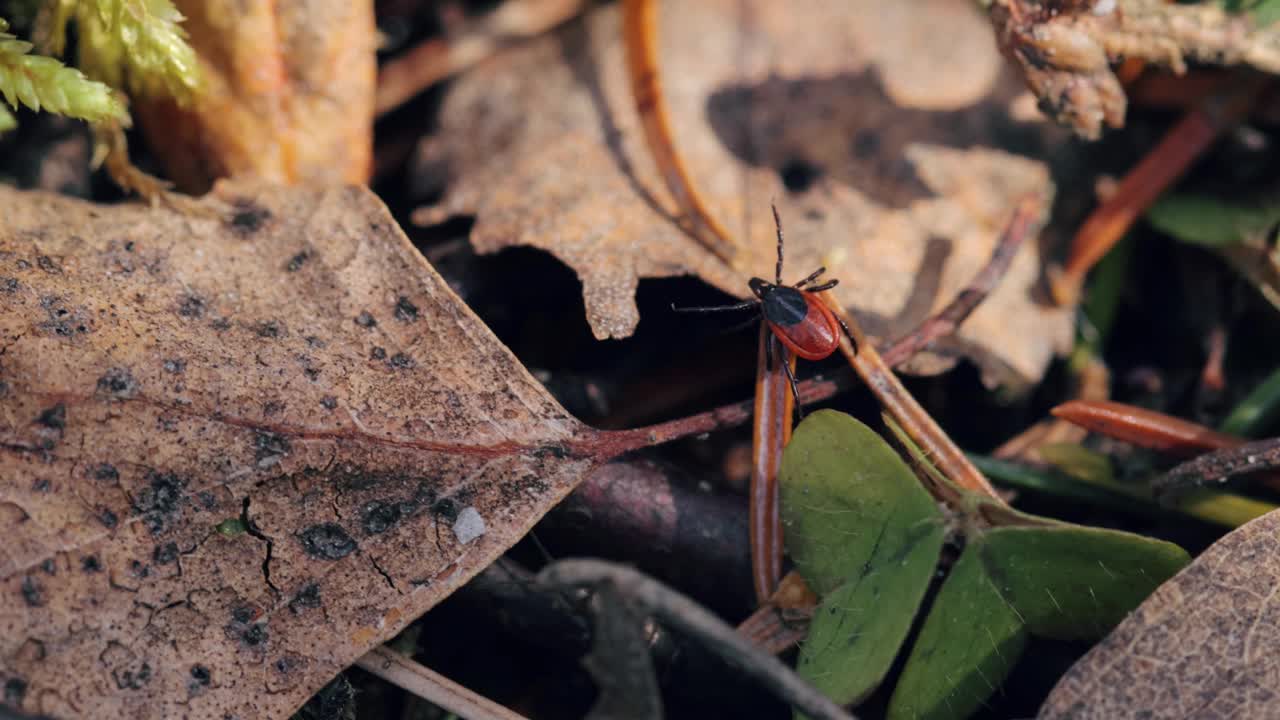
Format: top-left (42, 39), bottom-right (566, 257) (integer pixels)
top-left (677, 206), bottom-right (841, 410)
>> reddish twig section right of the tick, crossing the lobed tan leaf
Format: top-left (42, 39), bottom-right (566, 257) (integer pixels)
top-left (882, 195), bottom-right (1042, 368)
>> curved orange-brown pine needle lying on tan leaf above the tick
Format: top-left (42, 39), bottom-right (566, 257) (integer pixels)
top-left (622, 0), bottom-right (736, 264)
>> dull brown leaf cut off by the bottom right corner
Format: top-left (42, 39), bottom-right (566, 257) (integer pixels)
top-left (1039, 511), bottom-right (1280, 720)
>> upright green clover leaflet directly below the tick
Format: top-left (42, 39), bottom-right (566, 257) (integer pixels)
top-left (780, 410), bottom-right (945, 703)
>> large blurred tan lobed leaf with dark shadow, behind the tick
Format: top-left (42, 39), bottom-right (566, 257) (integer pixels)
top-left (415, 0), bottom-right (1071, 382)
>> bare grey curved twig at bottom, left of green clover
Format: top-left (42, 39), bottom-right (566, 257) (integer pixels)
top-left (538, 560), bottom-right (852, 720)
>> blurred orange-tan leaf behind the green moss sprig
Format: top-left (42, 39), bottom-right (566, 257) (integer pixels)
top-left (134, 0), bottom-right (378, 192)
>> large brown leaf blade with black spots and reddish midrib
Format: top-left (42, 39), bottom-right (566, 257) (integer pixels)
top-left (0, 184), bottom-right (596, 717)
